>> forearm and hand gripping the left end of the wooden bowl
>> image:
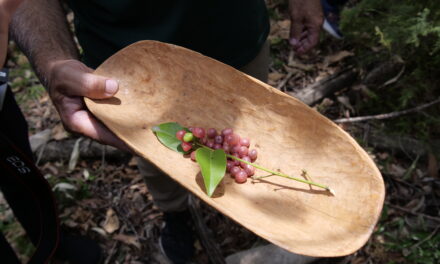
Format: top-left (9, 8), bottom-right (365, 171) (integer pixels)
top-left (11, 0), bottom-right (128, 150)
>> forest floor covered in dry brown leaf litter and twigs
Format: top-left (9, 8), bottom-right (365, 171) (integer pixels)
top-left (0, 1), bottom-right (440, 263)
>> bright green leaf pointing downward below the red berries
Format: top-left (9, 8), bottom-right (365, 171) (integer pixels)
top-left (196, 148), bottom-right (226, 197)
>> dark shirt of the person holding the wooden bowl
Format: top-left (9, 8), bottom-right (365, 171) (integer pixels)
top-left (68, 0), bottom-right (269, 68)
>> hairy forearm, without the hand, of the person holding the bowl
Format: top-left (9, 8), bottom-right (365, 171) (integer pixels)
top-left (11, 0), bottom-right (78, 87)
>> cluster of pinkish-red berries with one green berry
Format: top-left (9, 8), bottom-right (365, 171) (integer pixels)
top-left (176, 127), bottom-right (258, 183)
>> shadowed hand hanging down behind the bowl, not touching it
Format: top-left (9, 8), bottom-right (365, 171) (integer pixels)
top-left (289, 0), bottom-right (324, 54)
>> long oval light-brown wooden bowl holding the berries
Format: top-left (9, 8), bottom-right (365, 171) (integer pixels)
top-left (85, 41), bottom-right (385, 257)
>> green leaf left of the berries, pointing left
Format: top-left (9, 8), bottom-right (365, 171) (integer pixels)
top-left (151, 122), bottom-right (186, 153)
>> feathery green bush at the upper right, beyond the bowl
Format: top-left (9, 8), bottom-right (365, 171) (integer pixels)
top-left (341, 0), bottom-right (440, 139)
